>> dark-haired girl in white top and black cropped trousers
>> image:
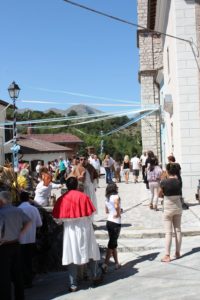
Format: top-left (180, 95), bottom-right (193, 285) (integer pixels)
top-left (102, 183), bottom-right (121, 272)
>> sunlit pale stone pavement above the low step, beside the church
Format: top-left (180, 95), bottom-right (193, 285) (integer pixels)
top-left (95, 177), bottom-right (200, 238)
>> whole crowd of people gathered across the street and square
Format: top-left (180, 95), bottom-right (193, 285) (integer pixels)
top-left (0, 151), bottom-right (186, 300)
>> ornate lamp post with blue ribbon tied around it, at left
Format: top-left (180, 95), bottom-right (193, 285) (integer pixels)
top-left (8, 81), bottom-right (20, 172)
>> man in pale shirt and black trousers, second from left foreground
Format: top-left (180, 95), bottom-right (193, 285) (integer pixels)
top-left (19, 192), bottom-right (42, 288)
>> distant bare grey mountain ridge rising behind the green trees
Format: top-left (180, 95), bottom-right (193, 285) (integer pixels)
top-left (18, 104), bottom-right (103, 116)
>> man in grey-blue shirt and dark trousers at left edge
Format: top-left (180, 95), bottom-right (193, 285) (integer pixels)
top-left (0, 191), bottom-right (31, 300)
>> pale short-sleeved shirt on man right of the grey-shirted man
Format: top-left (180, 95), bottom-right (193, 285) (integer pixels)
top-left (19, 202), bottom-right (42, 244)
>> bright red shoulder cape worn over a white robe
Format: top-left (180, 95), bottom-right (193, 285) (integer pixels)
top-left (52, 190), bottom-right (96, 219)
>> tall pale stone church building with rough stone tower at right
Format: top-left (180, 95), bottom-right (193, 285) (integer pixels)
top-left (138, 0), bottom-right (200, 199)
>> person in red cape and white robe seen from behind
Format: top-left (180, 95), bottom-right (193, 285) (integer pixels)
top-left (52, 177), bottom-right (102, 292)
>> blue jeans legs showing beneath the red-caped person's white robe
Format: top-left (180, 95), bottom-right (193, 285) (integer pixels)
top-left (68, 259), bottom-right (102, 286)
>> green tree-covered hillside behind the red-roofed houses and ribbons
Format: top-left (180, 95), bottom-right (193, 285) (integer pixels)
top-left (14, 110), bottom-right (142, 160)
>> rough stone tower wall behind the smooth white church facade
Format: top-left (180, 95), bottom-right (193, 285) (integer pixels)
top-left (138, 0), bottom-right (162, 158)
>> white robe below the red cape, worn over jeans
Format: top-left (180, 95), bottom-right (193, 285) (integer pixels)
top-left (62, 217), bottom-right (100, 265)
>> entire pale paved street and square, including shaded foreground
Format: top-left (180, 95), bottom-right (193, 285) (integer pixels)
top-left (26, 177), bottom-right (200, 300)
